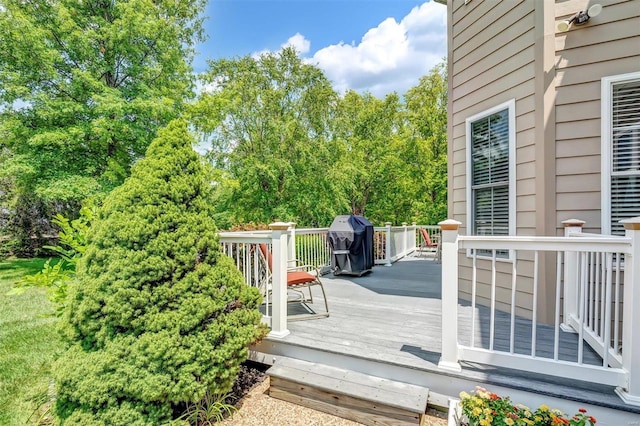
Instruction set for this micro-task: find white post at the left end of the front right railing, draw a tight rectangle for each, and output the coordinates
[438,219,462,371]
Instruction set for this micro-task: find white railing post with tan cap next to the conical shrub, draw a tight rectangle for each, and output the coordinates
[269,222,289,338]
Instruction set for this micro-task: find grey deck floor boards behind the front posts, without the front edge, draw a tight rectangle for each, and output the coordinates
[285,259,601,369]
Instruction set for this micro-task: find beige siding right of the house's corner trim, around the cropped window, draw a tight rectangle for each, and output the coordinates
[555,0,640,233]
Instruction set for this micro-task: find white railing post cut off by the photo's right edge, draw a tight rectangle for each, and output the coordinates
[616,217,640,406]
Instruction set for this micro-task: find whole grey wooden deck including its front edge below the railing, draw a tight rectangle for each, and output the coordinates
[253,257,640,420]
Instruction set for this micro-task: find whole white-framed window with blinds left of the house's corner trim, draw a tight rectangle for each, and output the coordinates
[466,100,515,257]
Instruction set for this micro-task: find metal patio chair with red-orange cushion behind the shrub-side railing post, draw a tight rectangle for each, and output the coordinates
[258,243,329,321]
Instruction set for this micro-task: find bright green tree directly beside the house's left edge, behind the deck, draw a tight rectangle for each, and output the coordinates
[334,63,447,224]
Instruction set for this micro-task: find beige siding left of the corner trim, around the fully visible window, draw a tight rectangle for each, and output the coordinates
[449,0,536,316]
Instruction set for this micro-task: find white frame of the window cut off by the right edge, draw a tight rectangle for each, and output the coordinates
[600,72,640,235]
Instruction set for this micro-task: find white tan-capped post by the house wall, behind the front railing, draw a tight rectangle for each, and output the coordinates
[560,219,585,333]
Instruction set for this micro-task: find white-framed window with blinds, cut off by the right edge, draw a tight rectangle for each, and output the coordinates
[601,73,640,235]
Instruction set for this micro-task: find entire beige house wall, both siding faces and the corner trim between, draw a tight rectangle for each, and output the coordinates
[448,0,640,320]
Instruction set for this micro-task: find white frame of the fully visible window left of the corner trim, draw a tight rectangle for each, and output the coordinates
[465,99,516,261]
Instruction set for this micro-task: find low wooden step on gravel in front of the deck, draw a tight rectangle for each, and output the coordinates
[267,357,429,425]
